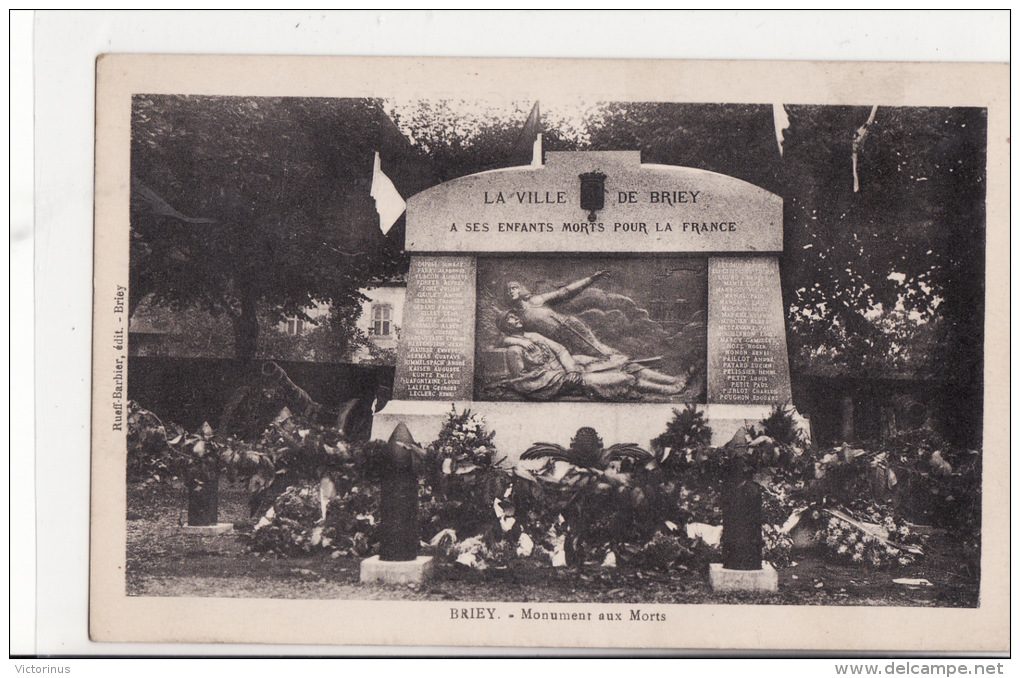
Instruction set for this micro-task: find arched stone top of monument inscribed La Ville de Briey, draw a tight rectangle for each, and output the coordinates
[406,151,782,254]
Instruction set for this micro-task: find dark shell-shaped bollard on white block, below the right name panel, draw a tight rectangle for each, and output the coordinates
[709,457,779,591]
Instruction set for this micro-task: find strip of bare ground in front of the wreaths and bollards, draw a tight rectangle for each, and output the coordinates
[126,482,978,607]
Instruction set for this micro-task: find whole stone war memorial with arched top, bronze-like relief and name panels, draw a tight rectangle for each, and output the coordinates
[372,151,792,459]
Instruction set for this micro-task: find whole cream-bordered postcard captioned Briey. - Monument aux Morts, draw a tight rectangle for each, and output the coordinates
[90,54,1010,653]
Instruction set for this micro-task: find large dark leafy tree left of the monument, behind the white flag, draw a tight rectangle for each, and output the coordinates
[131,95,419,362]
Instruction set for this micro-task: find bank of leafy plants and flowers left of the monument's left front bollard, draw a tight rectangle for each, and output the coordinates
[129,402,385,556]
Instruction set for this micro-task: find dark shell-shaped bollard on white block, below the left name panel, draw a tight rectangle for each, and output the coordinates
[361,422,432,584]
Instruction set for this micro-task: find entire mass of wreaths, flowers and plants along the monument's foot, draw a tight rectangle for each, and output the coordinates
[129,403,980,572]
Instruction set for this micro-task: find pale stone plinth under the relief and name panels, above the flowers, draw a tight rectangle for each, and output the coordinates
[372,401,810,462]
